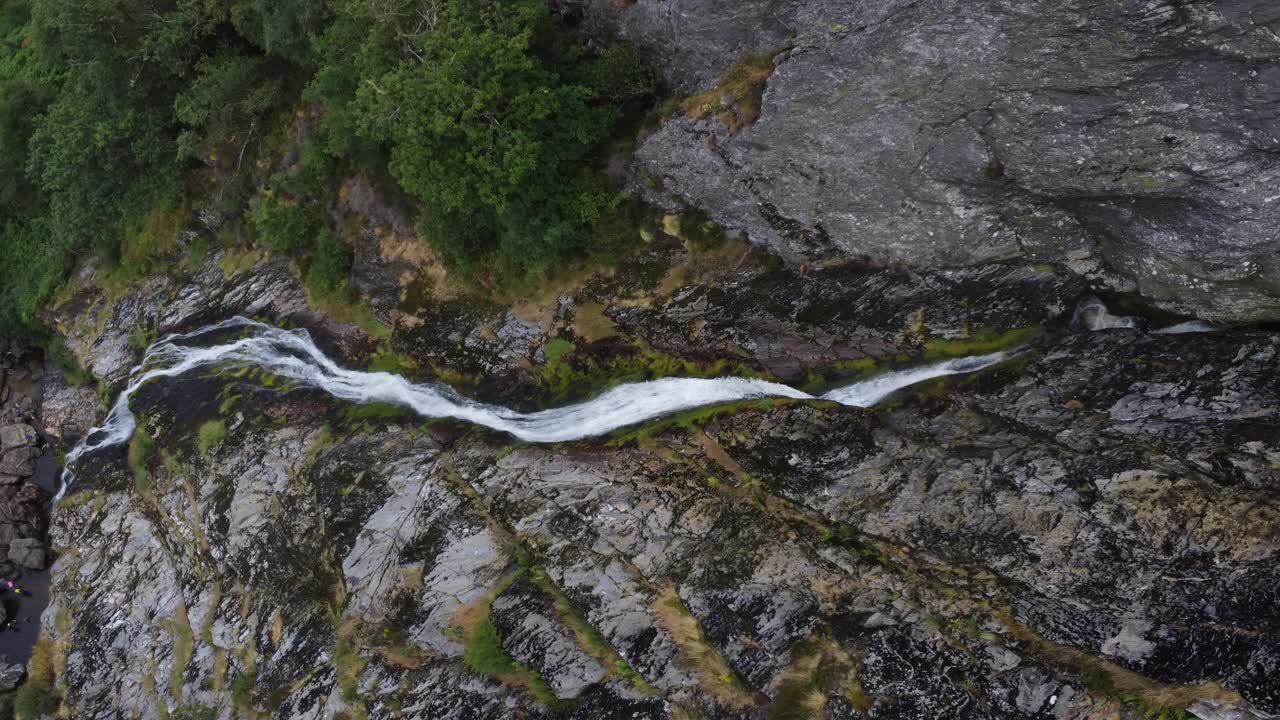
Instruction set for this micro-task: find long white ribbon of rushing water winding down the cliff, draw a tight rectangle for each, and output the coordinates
[58,318,1016,498]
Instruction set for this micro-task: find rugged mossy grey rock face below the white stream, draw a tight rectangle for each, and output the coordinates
[45,316,1280,720]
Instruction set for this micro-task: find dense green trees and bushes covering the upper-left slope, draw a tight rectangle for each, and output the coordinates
[0,0,655,334]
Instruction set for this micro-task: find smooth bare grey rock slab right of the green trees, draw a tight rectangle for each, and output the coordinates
[570,0,1280,320]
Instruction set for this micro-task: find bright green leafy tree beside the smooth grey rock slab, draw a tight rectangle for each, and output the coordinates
[308,0,653,273]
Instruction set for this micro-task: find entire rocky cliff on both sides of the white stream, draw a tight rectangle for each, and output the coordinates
[10,0,1280,720]
